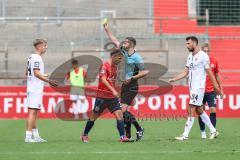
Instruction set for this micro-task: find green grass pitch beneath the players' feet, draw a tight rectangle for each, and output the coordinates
[0,119,240,160]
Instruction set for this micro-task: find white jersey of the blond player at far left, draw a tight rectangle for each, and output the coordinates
[27,54,44,93]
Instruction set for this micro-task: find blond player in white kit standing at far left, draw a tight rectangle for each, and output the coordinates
[25,39,57,143]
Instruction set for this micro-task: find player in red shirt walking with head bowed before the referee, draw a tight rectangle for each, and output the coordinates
[81,49,132,143]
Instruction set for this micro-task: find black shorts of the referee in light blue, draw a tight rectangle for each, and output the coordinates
[121,80,138,106]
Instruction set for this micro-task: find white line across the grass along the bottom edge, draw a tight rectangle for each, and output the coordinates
[0,150,240,155]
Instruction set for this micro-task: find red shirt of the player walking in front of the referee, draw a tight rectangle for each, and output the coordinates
[97,62,117,98]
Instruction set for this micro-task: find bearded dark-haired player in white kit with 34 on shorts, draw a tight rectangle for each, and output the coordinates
[169,36,222,140]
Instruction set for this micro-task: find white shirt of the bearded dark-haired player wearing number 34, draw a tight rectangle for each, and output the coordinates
[186,51,210,91]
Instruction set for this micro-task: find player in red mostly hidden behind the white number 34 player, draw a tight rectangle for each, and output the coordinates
[198,43,223,139]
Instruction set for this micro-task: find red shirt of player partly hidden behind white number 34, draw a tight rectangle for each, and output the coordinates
[205,56,219,93]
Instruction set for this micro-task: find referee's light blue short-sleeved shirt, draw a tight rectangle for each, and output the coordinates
[123,51,144,80]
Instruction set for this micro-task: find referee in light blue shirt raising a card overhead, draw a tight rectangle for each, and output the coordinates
[104,23,149,141]
